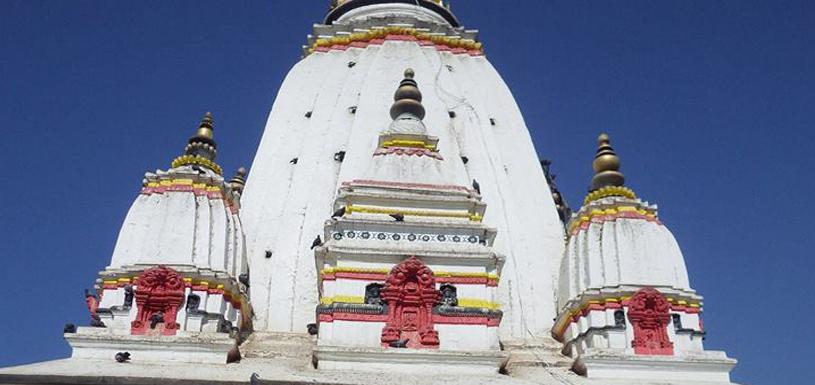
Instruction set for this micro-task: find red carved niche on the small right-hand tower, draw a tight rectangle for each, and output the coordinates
[628,288,674,356]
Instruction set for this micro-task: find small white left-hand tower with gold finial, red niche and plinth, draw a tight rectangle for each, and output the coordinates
[65,113,252,363]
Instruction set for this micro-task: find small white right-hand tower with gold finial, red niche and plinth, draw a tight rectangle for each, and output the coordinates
[552,134,736,384]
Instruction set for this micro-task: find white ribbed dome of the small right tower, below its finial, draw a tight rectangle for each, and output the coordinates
[558,197,692,307]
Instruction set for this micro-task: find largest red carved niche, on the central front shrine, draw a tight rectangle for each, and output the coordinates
[381,257,441,349]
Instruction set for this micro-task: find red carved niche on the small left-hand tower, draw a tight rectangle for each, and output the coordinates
[130,266,184,335]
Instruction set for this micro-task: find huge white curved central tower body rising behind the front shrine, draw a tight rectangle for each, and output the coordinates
[242,0,563,340]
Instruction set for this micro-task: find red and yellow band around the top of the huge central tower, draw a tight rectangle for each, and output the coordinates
[308,26,484,56]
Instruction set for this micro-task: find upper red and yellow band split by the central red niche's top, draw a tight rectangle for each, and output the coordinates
[320,267,499,287]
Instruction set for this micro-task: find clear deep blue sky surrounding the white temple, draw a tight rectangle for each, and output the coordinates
[0,0,815,384]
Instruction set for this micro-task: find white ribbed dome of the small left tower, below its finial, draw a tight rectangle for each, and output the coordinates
[109,166,246,277]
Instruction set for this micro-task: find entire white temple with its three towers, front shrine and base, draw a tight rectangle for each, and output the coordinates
[0,0,736,385]
